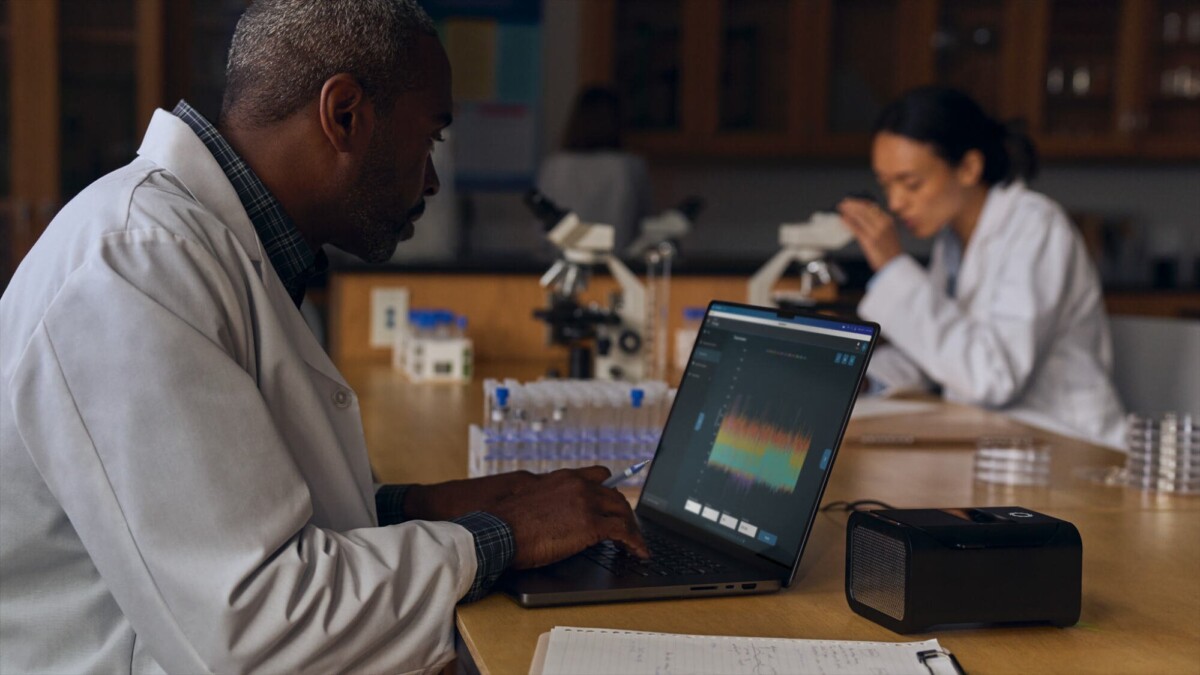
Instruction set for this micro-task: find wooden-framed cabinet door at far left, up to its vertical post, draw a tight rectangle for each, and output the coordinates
[2,0,163,280]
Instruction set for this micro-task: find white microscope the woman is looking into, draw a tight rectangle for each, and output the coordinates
[749,211,854,309]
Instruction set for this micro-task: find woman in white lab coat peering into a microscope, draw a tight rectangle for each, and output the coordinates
[838,86,1124,447]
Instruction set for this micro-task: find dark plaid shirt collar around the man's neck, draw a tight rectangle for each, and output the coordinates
[172,101,329,307]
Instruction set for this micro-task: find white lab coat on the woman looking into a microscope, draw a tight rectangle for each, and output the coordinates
[858,183,1124,448]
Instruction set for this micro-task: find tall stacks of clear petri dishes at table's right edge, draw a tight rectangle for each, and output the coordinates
[1124,412,1200,495]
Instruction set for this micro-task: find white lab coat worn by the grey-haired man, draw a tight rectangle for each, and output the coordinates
[0,110,476,673]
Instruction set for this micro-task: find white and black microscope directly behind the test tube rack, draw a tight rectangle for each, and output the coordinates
[524,190,647,381]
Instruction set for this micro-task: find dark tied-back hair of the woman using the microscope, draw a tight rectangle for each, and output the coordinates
[875,86,1038,186]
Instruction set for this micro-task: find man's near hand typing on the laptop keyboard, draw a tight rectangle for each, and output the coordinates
[487,466,649,569]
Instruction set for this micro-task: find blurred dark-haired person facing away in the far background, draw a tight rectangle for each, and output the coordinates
[538,86,652,253]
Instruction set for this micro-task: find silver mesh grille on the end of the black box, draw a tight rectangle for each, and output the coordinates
[850,527,906,621]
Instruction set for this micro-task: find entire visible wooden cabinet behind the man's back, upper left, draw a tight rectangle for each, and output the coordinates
[0,0,246,287]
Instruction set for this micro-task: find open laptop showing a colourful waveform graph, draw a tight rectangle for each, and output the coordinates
[500,301,880,607]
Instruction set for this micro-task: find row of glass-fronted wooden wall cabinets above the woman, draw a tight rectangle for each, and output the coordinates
[581,0,1200,159]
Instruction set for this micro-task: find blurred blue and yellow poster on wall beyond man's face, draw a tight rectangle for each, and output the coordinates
[421,0,541,191]
